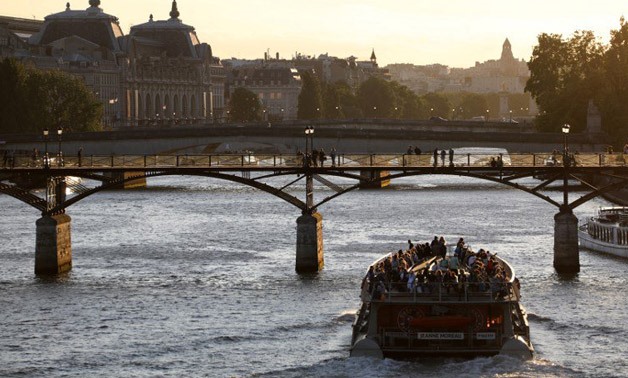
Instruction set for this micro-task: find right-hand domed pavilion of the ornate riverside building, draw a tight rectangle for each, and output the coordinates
[125,1,224,124]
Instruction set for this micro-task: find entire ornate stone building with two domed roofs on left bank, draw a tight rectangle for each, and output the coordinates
[20,0,224,128]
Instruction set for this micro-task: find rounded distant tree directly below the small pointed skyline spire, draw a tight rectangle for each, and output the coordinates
[357,76,395,118]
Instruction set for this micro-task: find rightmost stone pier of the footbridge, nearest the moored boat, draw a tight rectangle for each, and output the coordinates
[554,207,580,274]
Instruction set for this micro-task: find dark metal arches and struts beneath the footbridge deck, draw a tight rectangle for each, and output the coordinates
[0,166,628,215]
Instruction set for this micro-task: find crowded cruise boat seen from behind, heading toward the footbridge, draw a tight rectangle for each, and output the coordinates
[351,239,534,359]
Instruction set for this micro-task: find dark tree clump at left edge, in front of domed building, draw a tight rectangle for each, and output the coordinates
[0,58,102,134]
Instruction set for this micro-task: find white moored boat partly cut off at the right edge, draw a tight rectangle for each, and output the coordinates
[578,207,628,258]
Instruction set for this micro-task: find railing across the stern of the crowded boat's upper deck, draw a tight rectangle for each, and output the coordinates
[362,282,519,302]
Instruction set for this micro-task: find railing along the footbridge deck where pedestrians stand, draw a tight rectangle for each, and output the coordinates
[0,152,627,169]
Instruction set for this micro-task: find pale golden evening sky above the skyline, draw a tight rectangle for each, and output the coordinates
[0,0,628,68]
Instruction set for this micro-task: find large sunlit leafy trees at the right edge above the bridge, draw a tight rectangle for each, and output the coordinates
[526,17,628,145]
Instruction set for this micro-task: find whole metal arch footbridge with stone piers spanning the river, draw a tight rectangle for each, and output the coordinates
[0,150,628,274]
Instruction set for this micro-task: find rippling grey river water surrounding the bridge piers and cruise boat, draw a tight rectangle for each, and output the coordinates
[0,176,628,377]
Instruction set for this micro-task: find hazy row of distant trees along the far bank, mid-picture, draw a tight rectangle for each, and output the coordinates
[229,71,529,122]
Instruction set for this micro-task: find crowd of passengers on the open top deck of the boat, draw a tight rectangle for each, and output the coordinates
[364,236,508,299]
